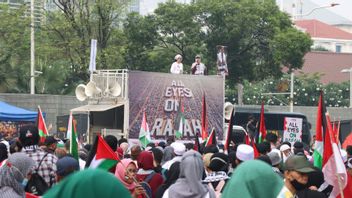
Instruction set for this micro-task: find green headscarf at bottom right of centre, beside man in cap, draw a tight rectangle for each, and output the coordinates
[222,160,283,198]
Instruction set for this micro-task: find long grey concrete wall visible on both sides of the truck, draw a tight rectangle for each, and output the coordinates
[0,93,352,133]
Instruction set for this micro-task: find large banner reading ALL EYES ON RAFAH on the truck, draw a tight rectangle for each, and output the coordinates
[128,71,224,139]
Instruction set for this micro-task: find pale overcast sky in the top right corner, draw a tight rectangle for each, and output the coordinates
[312,0,352,21]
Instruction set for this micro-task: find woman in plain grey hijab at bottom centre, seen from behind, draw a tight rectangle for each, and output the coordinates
[163,150,215,198]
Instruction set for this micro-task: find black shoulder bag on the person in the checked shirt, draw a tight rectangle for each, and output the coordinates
[25,153,49,195]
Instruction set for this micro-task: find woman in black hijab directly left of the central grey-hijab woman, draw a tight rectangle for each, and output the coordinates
[155,162,180,198]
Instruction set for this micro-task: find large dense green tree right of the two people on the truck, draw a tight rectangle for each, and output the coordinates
[197,0,311,83]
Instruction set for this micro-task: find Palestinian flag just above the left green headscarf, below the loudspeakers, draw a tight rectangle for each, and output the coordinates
[86,135,120,171]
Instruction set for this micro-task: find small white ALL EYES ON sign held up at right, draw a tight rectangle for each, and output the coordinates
[283,117,303,144]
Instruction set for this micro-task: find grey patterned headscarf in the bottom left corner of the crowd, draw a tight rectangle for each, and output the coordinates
[0,153,35,195]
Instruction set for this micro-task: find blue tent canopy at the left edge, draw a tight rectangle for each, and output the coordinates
[0,101,38,122]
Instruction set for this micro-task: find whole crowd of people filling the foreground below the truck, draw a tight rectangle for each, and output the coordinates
[0,126,352,198]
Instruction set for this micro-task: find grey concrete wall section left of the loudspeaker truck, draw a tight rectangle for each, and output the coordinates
[0,93,87,133]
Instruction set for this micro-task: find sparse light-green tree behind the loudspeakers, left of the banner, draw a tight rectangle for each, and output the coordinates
[46,0,128,82]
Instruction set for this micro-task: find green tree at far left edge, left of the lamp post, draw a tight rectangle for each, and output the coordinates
[0,5,30,92]
